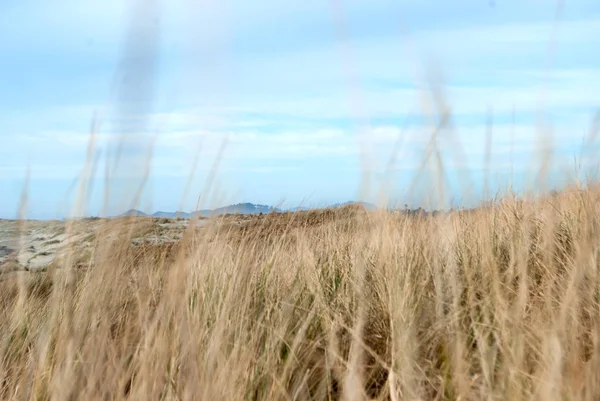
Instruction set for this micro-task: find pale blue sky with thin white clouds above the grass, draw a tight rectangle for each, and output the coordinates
[0,0,600,219]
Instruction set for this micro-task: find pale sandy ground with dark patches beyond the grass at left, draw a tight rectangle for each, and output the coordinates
[0,218,196,273]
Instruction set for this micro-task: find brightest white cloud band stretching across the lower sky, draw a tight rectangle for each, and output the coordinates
[0,113,584,179]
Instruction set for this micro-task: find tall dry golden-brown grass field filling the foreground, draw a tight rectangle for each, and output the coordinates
[0,187,600,401]
